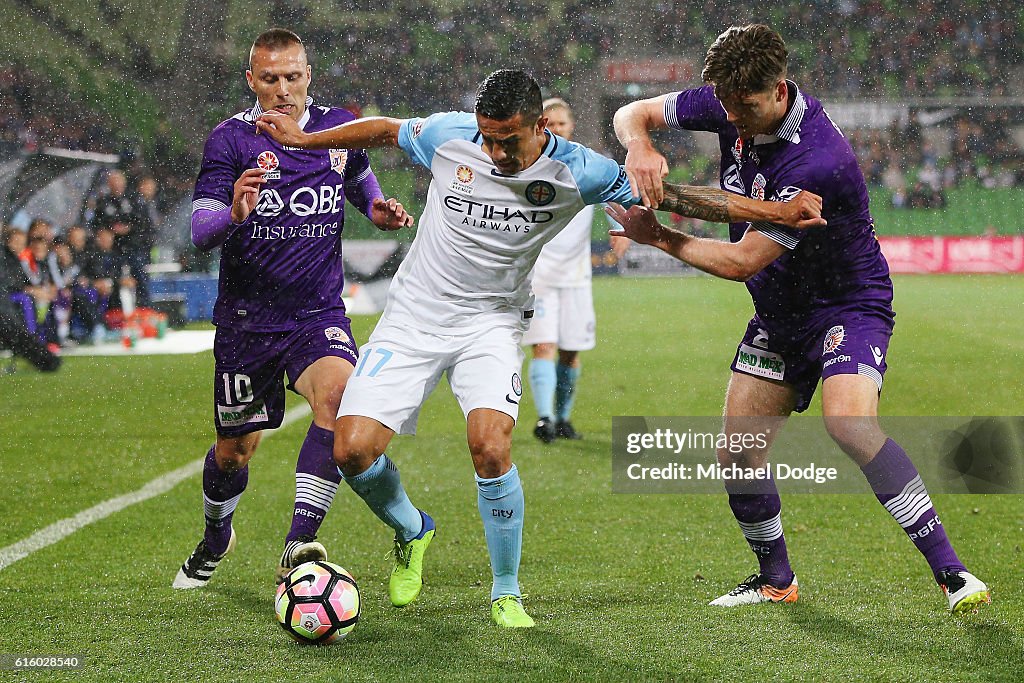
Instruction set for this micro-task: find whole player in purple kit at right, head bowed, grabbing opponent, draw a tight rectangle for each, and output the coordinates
[608,25,989,612]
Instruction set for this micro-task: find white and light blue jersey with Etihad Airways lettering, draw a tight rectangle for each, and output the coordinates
[384,112,636,335]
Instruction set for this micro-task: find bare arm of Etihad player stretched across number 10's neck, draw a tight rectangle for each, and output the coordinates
[255,112,402,150]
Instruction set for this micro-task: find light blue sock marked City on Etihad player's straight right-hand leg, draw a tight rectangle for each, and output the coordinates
[476,465,525,600]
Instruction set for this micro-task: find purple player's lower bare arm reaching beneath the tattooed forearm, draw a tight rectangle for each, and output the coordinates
[605,203,785,282]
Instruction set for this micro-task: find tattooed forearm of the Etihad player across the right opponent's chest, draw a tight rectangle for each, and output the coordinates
[657,182,827,229]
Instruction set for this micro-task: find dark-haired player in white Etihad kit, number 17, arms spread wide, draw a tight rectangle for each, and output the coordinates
[257,70,823,628]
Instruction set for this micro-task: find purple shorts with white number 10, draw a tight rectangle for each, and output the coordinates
[213,310,359,436]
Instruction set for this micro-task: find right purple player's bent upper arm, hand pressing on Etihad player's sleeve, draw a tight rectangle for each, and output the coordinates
[613,94,669,209]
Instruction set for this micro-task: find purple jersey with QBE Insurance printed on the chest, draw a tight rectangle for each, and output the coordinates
[193,98,376,332]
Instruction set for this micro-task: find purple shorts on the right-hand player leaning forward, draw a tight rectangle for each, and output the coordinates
[732,312,893,413]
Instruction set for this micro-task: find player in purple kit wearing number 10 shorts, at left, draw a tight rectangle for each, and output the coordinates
[173,29,413,589]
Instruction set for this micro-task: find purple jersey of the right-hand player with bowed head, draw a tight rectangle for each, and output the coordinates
[665,81,894,334]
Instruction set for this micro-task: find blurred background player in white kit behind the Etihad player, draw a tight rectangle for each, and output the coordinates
[522,97,630,443]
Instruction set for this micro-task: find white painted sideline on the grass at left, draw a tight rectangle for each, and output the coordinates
[0,403,311,571]
